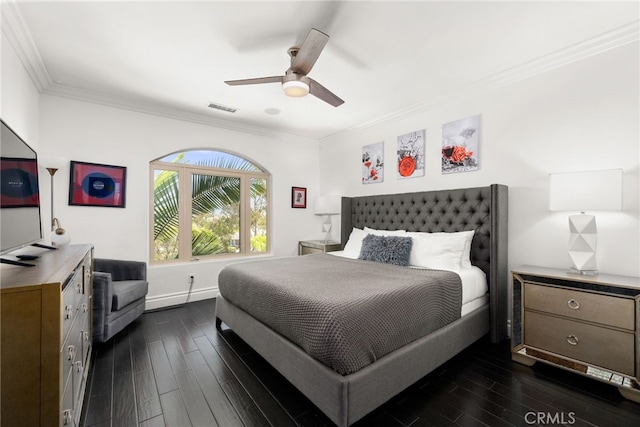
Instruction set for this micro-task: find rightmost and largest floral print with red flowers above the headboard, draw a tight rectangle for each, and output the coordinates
[442,115,480,174]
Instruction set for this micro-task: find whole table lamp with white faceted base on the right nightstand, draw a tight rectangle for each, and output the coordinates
[549,169,622,275]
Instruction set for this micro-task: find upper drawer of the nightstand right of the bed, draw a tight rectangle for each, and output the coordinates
[524,283,635,331]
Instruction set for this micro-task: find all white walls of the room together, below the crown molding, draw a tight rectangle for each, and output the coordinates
[0,26,640,308]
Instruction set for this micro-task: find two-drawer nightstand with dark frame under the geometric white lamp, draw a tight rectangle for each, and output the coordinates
[511,266,640,402]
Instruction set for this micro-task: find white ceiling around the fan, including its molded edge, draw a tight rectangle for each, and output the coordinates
[2,0,639,140]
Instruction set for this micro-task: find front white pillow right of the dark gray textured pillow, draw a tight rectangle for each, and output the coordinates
[407,230,475,271]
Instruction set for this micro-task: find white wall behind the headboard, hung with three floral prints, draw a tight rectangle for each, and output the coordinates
[320,43,640,276]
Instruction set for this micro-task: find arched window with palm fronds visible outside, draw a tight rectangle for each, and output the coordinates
[150,150,270,263]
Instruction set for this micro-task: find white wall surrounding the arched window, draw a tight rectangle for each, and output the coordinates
[35,95,321,308]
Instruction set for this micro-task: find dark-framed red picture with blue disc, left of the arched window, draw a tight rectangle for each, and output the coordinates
[69,161,127,208]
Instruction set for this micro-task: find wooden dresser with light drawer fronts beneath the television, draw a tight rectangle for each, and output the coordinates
[0,245,93,427]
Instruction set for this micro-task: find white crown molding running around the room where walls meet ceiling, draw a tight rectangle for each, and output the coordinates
[1,0,640,141]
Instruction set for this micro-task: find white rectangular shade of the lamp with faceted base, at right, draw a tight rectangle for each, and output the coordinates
[549,169,622,212]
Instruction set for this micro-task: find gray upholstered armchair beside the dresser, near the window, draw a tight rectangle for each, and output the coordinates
[93,258,149,342]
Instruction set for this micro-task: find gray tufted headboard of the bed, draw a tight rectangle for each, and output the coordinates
[341,184,508,342]
